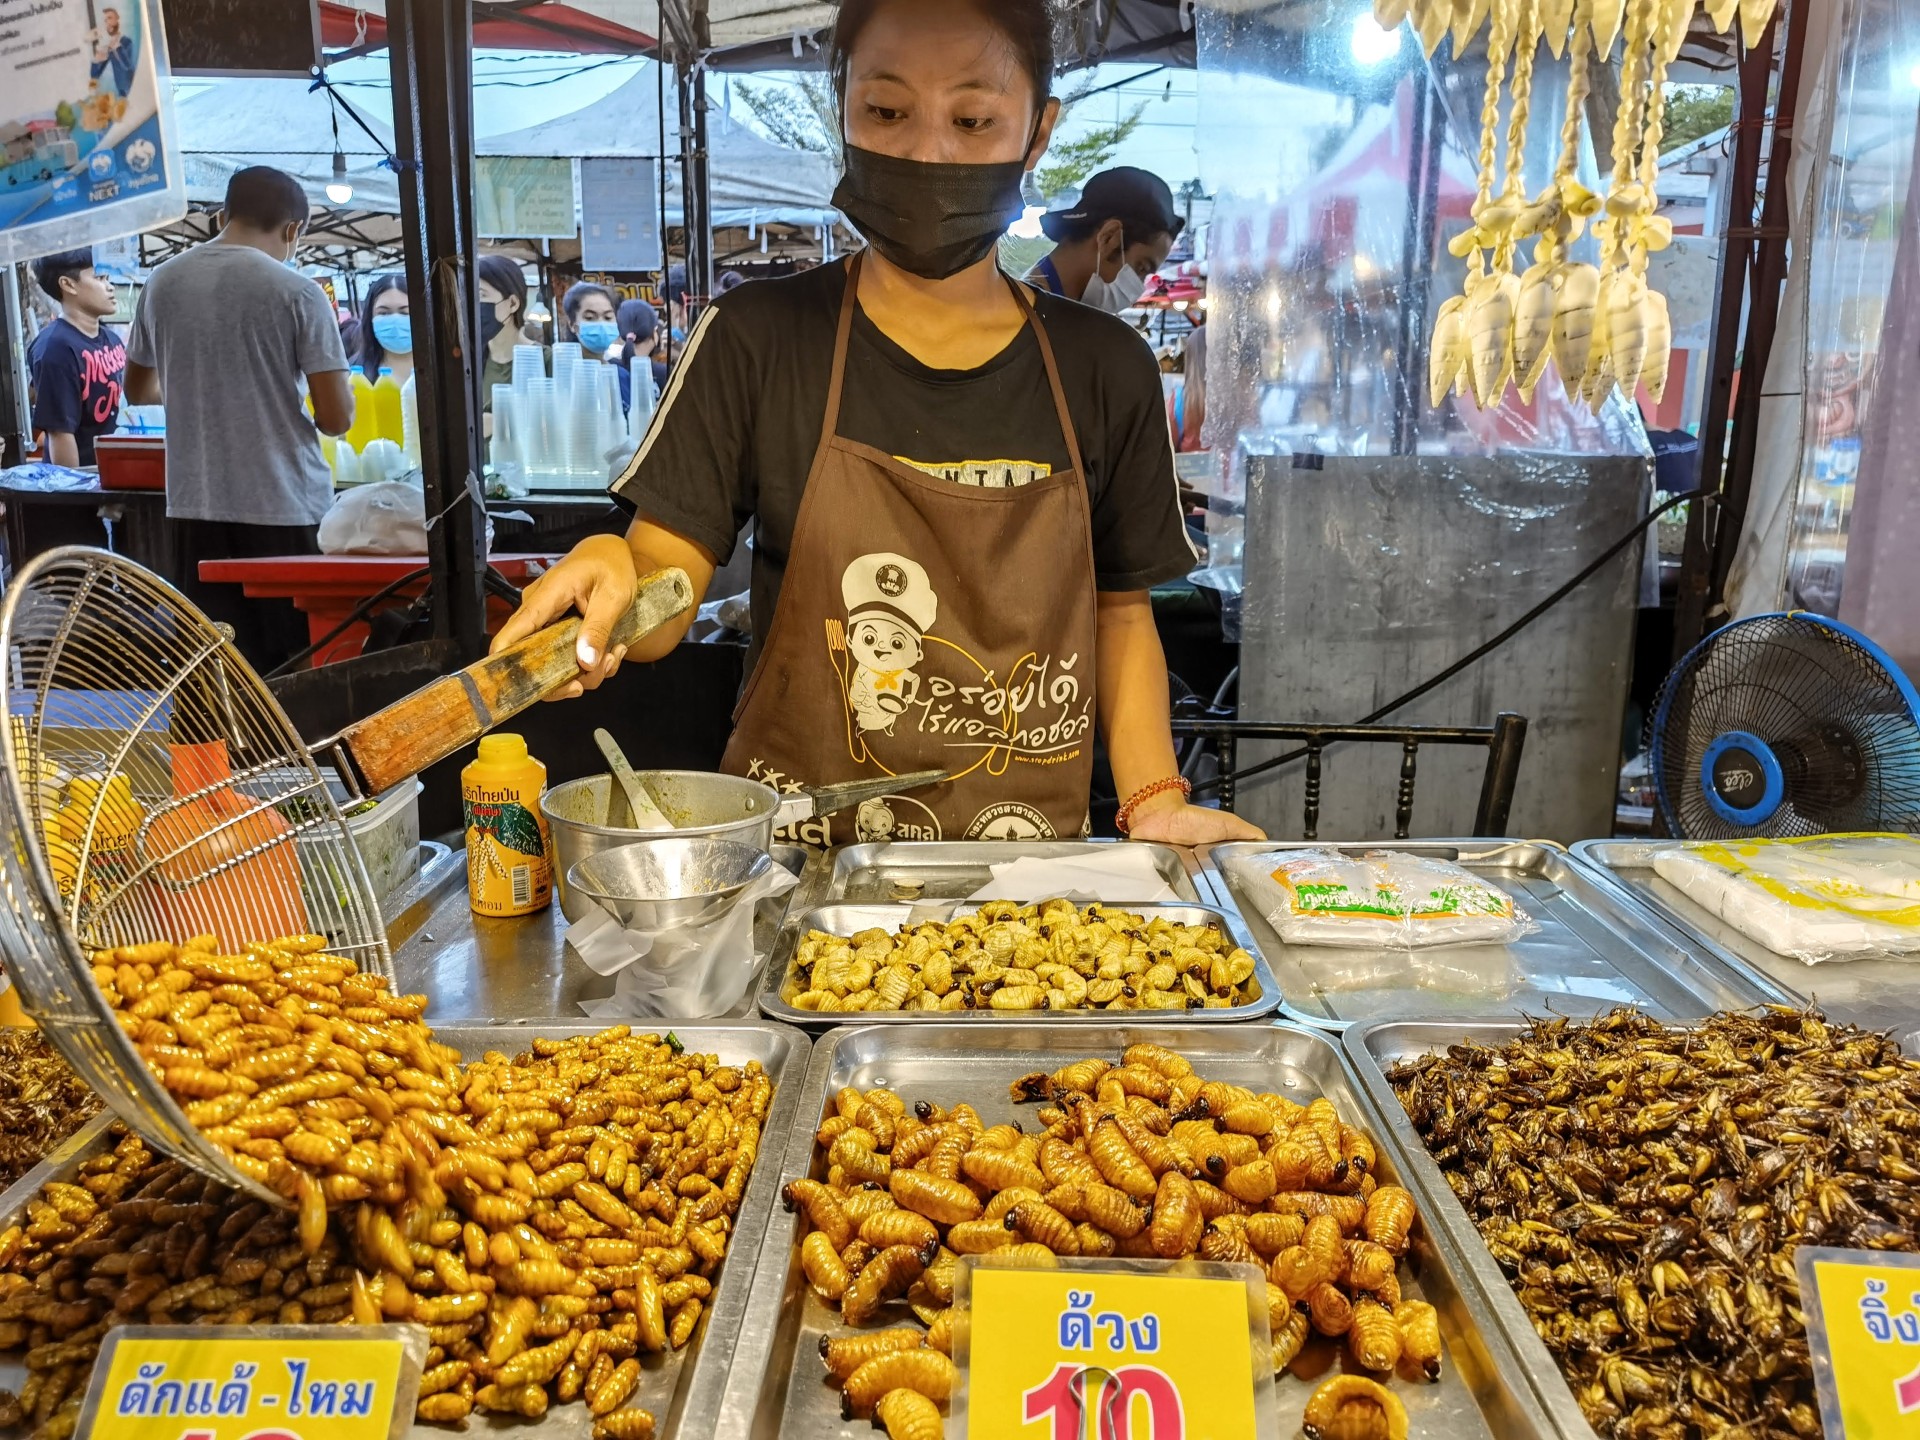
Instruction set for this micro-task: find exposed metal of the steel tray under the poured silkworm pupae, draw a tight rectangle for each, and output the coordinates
[0,1021,816,1440]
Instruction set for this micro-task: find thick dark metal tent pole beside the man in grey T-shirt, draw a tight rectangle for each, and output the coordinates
[386,0,486,657]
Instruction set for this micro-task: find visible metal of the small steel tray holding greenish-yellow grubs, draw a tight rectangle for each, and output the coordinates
[760,900,1281,1029]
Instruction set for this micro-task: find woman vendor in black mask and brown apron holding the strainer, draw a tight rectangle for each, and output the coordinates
[495,0,1258,845]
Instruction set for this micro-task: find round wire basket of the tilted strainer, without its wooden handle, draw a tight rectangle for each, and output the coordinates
[0,549,392,1204]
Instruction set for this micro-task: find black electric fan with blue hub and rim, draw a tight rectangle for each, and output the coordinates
[1649,611,1920,839]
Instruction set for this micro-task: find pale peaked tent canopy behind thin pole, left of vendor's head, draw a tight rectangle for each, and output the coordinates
[474,65,839,228]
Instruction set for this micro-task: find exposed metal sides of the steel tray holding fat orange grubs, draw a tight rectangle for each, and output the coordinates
[718,1021,1551,1440]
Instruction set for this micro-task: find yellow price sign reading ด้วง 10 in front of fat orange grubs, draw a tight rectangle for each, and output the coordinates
[954,1256,1279,1440]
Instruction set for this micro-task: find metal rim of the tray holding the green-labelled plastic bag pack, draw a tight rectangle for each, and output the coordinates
[1196,837,1791,1035]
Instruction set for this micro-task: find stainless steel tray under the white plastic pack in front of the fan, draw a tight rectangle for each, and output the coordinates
[1572,839,1920,1048]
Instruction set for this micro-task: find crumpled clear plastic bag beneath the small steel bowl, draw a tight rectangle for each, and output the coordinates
[566,864,801,1020]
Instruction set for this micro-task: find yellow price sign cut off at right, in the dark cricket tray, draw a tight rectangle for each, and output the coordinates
[1795,1246,1920,1440]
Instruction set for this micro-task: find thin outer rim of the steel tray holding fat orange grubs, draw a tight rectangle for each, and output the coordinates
[718,1016,1559,1440]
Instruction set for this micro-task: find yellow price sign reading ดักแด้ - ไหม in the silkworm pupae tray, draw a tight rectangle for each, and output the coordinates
[79,1325,426,1440]
